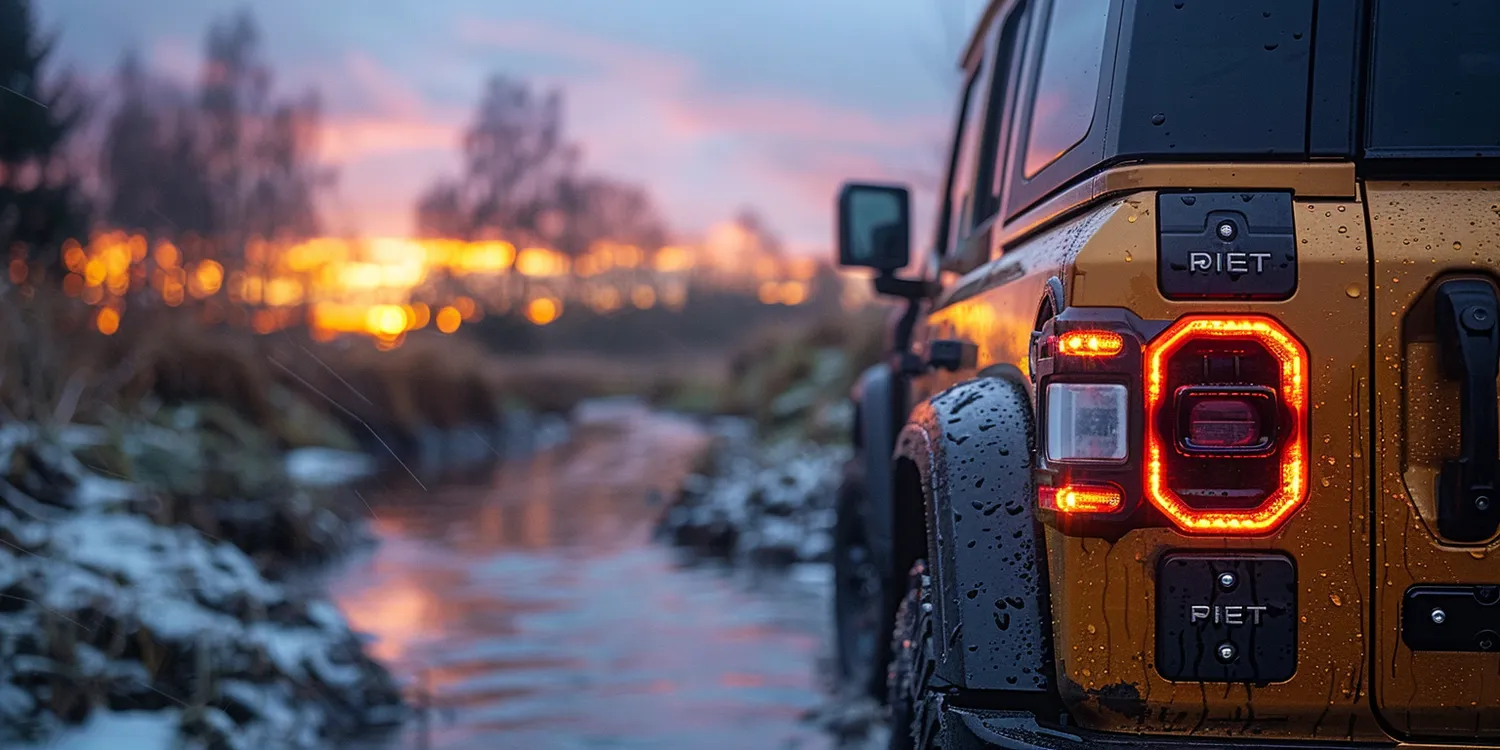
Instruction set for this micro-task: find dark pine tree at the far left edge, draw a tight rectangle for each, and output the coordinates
[0,0,86,265]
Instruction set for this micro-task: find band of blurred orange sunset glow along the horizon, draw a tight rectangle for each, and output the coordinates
[41,230,866,347]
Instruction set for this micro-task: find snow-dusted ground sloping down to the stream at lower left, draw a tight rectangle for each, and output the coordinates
[0,425,405,750]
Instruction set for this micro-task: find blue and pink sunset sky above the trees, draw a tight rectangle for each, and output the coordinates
[38,0,980,251]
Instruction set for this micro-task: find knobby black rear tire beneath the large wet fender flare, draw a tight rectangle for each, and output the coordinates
[887,560,942,750]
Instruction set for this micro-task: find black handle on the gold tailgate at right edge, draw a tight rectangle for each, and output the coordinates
[1436,279,1500,542]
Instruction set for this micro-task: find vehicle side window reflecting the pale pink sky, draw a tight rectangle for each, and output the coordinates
[1023,0,1110,180]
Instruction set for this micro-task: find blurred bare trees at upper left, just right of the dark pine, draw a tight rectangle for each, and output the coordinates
[101,11,333,267]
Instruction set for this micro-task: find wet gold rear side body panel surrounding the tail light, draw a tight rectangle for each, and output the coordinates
[930,172,1386,741]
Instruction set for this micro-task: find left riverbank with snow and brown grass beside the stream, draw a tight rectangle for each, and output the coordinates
[0,417,407,749]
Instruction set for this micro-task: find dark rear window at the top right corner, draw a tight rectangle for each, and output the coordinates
[1365,0,1500,156]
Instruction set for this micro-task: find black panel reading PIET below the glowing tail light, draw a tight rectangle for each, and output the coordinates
[1157,552,1298,684]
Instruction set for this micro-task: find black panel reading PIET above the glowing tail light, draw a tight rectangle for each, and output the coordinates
[1157,192,1298,300]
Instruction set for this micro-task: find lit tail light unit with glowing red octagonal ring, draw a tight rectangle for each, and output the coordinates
[1032,308,1310,536]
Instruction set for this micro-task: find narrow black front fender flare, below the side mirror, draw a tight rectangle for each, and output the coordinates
[854,363,906,570]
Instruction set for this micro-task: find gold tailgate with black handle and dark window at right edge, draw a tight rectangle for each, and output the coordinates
[1362,2,1500,744]
